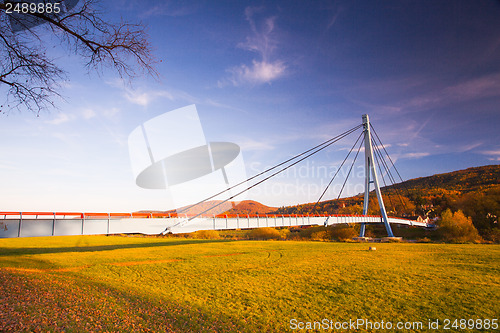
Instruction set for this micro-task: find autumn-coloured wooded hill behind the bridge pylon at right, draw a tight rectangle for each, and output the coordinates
[276,165,500,240]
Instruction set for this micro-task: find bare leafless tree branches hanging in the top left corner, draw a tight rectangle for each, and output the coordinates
[0,0,157,113]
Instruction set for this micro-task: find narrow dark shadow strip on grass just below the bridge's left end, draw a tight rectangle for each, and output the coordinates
[0,239,233,256]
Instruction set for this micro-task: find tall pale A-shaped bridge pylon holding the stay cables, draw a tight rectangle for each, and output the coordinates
[359,114,394,237]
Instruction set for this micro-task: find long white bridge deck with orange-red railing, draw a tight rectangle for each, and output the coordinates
[0,212,428,238]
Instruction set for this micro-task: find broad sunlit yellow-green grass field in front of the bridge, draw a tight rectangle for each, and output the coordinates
[0,236,500,332]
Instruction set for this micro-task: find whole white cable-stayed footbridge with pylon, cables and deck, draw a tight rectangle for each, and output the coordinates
[0,115,429,238]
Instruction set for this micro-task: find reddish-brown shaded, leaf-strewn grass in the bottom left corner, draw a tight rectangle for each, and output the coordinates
[0,270,256,332]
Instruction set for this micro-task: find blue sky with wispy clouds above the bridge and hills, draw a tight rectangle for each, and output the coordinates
[0,0,500,212]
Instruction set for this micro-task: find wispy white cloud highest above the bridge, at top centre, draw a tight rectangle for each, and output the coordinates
[219,7,287,87]
